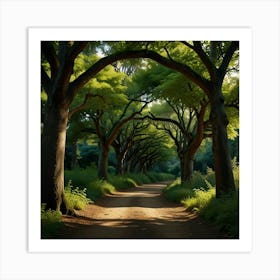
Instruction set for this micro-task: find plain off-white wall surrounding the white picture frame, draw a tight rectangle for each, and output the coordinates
[0,0,280,280]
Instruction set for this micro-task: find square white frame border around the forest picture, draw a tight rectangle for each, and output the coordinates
[28,27,252,253]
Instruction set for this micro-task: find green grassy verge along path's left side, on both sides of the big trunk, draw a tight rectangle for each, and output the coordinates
[41,167,174,238]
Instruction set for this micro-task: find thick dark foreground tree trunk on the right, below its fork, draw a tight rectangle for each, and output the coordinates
[210,86,235,197]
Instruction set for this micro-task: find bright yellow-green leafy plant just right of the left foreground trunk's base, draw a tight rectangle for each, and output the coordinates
[64,180,91,211]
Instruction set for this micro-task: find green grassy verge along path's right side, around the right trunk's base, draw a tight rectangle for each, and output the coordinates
[163,164,239,238]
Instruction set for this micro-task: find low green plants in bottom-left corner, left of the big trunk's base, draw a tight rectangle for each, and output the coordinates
[41,204,64,238]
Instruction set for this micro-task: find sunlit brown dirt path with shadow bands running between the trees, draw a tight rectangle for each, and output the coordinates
[56,183,229,239]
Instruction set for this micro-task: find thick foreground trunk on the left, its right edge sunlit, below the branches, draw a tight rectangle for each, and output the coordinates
[41,105,68,211]
